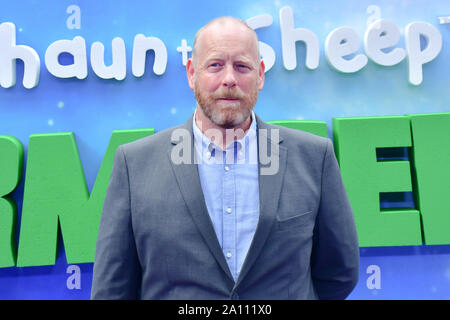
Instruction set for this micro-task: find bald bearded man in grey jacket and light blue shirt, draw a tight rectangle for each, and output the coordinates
[92,17,359,300]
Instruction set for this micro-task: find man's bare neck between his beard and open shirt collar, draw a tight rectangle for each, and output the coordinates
[195,105,252,150]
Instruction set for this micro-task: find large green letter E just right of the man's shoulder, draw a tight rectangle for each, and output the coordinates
[333,116,422,247]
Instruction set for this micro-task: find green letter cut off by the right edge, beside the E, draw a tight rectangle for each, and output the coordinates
[410,113,450,244]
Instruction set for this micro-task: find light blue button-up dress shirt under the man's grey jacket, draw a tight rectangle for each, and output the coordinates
[193,112,259,281]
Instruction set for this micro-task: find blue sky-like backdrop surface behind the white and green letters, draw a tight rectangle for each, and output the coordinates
[0,0,450,299]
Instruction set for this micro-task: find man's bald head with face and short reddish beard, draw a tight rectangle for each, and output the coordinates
[186,17,265,131]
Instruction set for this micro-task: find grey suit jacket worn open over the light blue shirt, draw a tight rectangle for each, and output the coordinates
[91,117,359,299]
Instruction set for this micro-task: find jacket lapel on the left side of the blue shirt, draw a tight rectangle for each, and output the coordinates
[168,116,234,282]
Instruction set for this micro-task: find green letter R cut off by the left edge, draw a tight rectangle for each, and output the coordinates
[0,136,23,268]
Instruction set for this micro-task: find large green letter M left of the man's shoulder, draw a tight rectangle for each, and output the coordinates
[17,129,153,267]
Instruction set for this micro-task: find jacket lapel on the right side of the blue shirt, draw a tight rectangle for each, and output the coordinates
[235,116,287,287]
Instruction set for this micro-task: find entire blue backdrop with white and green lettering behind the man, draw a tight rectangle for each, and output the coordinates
[0,0,450,299]
